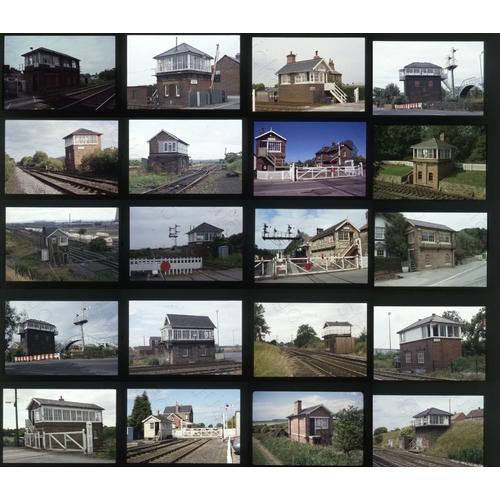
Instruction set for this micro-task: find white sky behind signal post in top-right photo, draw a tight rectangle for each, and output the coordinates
[373,40,484,92]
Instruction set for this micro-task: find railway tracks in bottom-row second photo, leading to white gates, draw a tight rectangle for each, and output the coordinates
[127,439,209,464]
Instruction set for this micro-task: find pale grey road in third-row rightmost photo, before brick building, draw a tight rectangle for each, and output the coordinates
[375,262,487,287]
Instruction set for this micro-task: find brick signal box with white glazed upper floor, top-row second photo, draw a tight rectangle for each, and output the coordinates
[153,43,229,108]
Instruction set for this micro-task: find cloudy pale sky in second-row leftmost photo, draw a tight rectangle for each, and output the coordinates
[5,120,118,161]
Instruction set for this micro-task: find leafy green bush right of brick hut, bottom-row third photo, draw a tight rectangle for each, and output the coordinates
[333,405,363,456]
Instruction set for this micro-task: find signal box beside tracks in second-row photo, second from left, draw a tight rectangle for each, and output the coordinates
[147,130,189,174]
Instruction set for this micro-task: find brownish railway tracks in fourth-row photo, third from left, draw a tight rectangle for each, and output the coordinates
[285,348,367,377]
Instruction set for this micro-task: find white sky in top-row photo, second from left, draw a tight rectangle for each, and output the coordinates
[127,35,241,86]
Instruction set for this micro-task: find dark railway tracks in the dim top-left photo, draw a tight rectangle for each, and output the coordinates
[43,81,116,111]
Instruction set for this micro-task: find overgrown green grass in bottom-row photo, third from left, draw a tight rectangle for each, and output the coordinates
[254,434,363,467]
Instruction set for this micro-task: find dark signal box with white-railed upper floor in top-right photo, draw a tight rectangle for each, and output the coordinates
[399,62,447,104]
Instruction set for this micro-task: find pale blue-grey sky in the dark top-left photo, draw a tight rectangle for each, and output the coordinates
[4,35,116,75]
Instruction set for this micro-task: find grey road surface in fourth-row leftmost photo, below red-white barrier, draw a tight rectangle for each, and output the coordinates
[5,358,118,376]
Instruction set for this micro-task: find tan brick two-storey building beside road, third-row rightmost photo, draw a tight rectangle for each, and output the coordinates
[405,219,456,270]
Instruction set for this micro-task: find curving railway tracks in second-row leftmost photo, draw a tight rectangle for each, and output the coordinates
[18,167,118,195]
